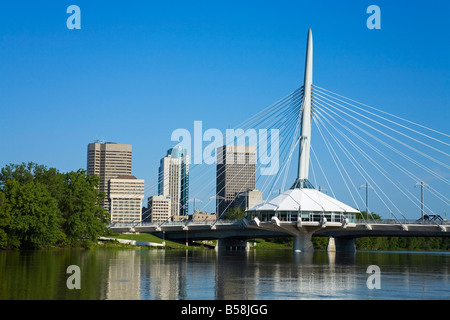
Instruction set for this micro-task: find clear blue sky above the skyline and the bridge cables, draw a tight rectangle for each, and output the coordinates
[0,0,450,218]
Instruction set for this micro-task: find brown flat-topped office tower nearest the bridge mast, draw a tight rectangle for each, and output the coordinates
[216,145,256,218]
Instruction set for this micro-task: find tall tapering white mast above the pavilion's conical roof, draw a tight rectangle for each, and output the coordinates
[291,28,314,189]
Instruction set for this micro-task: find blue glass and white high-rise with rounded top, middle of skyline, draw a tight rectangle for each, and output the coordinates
[158,147,189,217]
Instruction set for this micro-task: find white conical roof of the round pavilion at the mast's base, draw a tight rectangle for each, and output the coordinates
[247,188,359,213]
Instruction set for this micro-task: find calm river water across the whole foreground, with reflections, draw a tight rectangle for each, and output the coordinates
[0,249,450,300]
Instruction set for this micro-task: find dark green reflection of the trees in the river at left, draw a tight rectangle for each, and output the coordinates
[0,249,107,300]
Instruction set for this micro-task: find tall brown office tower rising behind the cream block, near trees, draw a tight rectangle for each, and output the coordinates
[87,141,132,211]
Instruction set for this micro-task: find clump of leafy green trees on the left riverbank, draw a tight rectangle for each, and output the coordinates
[0,162,109,247]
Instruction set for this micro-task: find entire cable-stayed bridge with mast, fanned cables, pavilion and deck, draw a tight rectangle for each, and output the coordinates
[111,30,450,252]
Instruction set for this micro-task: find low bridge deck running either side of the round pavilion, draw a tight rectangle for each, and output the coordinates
[110,219,450,251]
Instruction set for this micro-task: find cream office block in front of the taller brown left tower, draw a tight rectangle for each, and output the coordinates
[108,175,144,223]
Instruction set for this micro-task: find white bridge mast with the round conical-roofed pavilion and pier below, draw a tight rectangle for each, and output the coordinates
[247,29,359,252]
